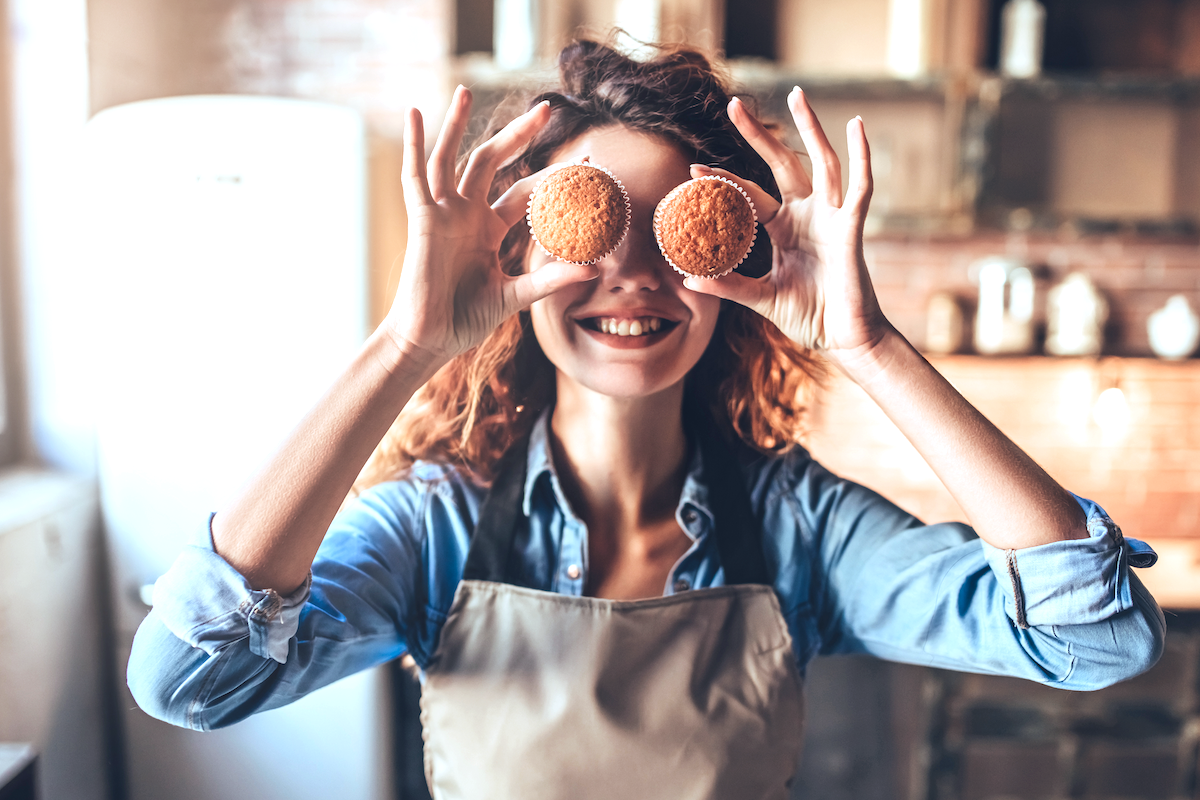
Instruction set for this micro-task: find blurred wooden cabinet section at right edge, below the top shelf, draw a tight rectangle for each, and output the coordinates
[966,76,1200,235]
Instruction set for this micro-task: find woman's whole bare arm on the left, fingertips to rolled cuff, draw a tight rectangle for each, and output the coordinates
[212,92,595,594]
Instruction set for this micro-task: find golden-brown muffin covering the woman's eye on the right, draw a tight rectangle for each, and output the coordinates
[654,175,758,278]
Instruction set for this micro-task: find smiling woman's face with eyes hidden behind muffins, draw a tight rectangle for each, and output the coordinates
[527,126,721,398]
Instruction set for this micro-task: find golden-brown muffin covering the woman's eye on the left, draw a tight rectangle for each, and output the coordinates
[528,162,629,264]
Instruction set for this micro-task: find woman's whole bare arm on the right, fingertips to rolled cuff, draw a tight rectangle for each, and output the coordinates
[686,88,1088,549]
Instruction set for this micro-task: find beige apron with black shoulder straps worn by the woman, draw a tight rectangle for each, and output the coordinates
[421,412,803,800]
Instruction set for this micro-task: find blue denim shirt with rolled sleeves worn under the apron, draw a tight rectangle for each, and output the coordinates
[128,415,1165,730]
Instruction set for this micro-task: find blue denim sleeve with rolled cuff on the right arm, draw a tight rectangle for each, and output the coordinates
[790,462,1165,690]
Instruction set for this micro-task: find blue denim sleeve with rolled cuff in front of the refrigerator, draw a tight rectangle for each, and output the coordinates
[127,485,422,730]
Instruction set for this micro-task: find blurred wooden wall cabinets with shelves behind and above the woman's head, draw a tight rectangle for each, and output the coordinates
[456,0,1200,236]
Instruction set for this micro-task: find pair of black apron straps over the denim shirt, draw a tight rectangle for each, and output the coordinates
[462,404,770,588]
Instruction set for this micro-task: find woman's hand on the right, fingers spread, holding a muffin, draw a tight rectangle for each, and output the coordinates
[685,88,890,367]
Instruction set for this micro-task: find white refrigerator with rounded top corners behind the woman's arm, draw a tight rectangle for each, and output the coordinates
[80,96,392,800]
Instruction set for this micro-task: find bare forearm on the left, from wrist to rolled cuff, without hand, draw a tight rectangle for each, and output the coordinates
[212,330,440,594]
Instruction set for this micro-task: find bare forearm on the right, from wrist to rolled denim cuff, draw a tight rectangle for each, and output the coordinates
[839,326,1087,549]
